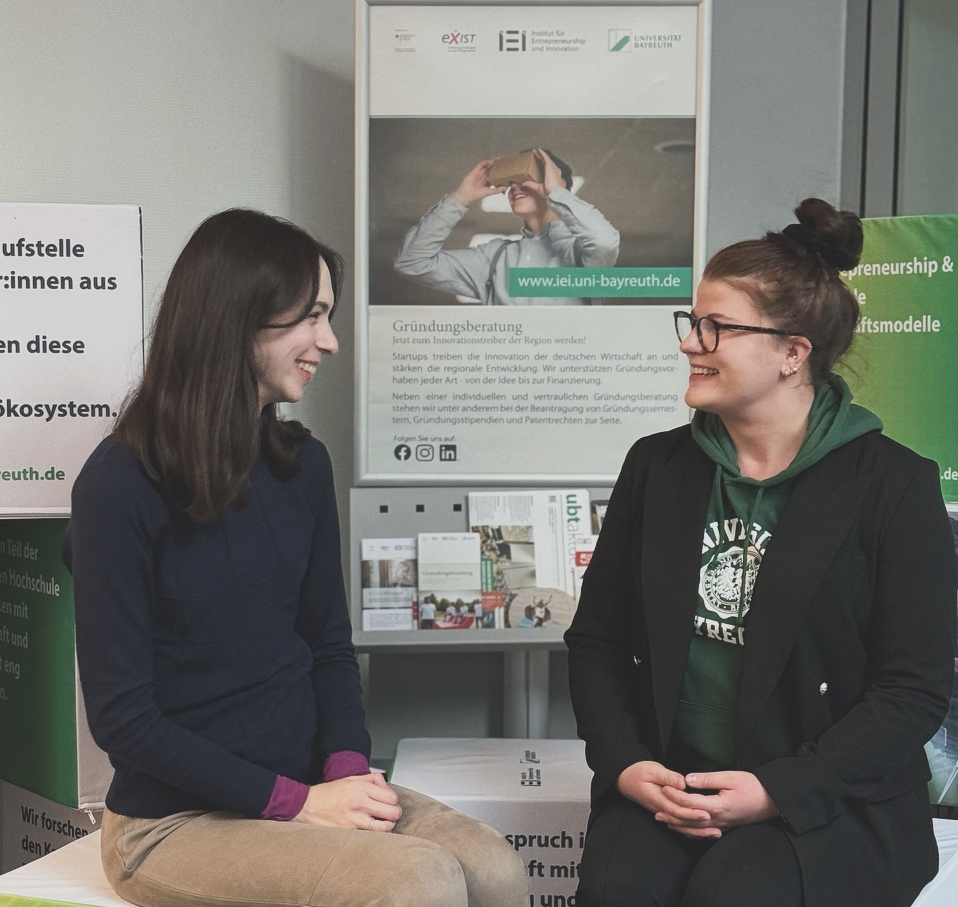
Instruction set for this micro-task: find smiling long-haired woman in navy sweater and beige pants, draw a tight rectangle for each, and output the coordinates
[64,210,528,907]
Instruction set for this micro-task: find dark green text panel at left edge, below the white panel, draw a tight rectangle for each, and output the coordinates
[0,519,77,806]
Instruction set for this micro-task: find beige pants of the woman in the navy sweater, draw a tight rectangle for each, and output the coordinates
[101,786,529,907]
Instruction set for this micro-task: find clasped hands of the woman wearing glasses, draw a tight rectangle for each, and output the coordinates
[617,762,780,839]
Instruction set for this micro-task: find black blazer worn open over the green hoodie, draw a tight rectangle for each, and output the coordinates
[566,426,956,907]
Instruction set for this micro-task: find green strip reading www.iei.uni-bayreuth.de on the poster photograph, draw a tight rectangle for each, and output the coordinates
[509,268,692,298]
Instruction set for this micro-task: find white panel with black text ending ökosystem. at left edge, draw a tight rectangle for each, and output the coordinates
[0,203,143,517]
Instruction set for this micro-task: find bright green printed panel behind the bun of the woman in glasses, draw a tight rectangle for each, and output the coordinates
[842,214,958,501]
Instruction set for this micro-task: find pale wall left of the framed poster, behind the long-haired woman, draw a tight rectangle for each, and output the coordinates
[0,0,354,510]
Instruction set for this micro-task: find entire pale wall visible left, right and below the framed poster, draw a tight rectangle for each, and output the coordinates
[0,0,845,758]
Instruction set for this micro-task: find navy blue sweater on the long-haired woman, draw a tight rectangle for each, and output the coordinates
[64,438,370,818]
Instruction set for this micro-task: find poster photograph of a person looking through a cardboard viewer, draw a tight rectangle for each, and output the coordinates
[369,117,695,306]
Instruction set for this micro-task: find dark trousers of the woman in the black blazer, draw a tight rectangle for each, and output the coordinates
[576,793,802,907]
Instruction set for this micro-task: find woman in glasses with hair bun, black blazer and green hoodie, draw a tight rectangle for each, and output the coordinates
[566,198,956,907]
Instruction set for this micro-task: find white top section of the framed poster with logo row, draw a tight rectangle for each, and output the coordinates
[369,6,698,117]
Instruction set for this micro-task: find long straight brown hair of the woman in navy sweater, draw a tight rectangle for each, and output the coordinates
[114,208,344,522]
